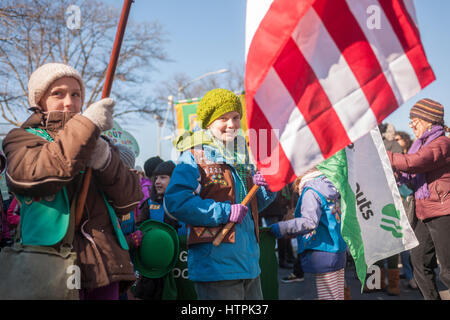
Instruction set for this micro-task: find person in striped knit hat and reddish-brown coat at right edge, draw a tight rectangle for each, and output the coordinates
[388,99,450,300]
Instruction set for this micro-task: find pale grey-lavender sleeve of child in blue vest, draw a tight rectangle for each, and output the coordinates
[278,190,322,236]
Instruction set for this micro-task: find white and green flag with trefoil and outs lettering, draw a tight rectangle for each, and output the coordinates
[317,127,419,285]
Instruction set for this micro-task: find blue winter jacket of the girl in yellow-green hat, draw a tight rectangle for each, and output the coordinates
[164,145,276,281]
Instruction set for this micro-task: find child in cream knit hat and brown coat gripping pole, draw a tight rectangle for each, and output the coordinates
[3,63,142,299]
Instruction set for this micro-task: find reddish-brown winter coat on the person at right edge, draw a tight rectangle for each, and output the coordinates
[388,136,450,220]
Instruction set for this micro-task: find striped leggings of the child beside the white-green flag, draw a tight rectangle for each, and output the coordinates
[316,269,345,300]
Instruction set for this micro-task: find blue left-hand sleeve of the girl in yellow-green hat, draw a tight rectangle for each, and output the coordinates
[164,151,231,227]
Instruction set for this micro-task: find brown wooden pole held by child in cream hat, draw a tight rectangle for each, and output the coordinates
[75,0,134,226]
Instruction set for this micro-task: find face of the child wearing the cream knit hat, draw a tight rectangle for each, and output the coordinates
[39,77,81,113]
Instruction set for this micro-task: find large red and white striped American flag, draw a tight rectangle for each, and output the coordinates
[245,0,435,190]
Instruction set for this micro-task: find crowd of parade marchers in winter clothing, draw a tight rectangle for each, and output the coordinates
[0,63,450,300]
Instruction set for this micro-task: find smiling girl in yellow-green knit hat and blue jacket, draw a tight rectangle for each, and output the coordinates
[164,89,276,300]
